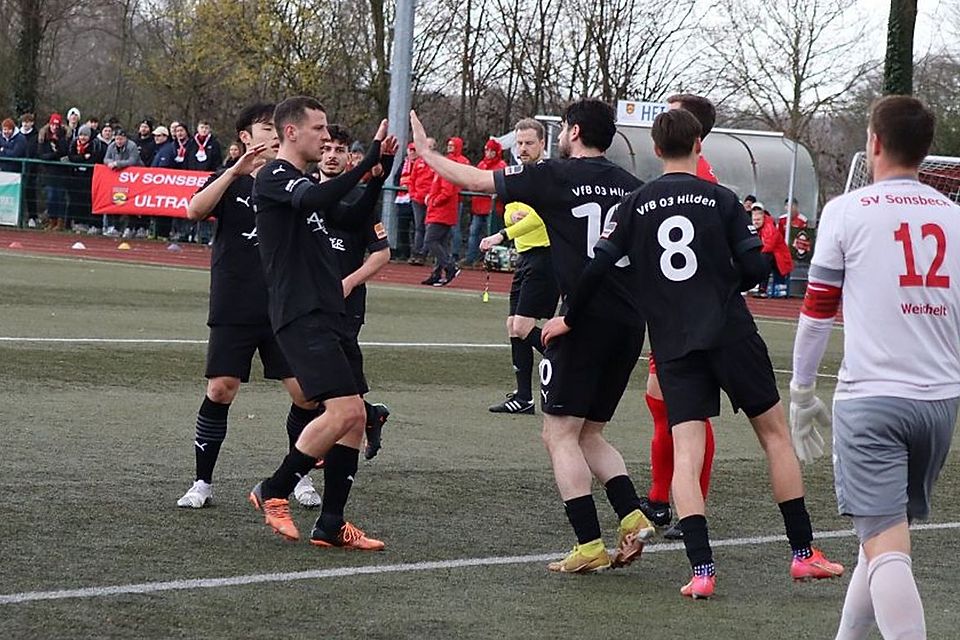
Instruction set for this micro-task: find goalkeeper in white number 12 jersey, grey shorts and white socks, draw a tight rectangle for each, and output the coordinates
[790,96,960,640]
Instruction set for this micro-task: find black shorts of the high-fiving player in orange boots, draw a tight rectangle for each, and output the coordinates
[277,311,360,402]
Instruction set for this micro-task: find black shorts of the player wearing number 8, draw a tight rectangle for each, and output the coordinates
[657,333,780,427]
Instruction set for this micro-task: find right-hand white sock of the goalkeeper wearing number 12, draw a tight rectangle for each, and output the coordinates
[868,552,927,640]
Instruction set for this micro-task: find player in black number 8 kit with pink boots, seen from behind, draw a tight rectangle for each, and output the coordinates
[543,110,843,598]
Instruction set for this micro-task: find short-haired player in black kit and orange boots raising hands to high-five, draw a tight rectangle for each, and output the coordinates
[249,96,397,550]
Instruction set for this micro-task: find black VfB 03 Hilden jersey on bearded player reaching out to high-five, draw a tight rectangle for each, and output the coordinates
[494,157,643,325]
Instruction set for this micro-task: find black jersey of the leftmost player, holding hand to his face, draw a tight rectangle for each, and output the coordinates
[200,171,270,326]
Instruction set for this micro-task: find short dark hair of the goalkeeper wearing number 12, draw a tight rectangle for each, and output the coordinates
[869,96,936,167]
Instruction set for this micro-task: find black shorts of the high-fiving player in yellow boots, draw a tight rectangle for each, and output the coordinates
[540,316,644,422]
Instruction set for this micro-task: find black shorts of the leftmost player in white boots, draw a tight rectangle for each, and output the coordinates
[204,323,293,382]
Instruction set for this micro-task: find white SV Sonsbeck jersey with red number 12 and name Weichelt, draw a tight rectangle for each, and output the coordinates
[804,179,960,400]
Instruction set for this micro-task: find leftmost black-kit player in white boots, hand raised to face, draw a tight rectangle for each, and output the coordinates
[177,103,320,509]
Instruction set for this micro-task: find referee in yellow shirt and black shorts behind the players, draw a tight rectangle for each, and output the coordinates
[480,118,560,414]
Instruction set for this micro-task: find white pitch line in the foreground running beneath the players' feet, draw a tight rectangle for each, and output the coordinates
[0,522,960,604]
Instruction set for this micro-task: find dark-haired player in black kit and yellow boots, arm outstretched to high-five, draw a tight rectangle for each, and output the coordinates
[410,99,654,573]
